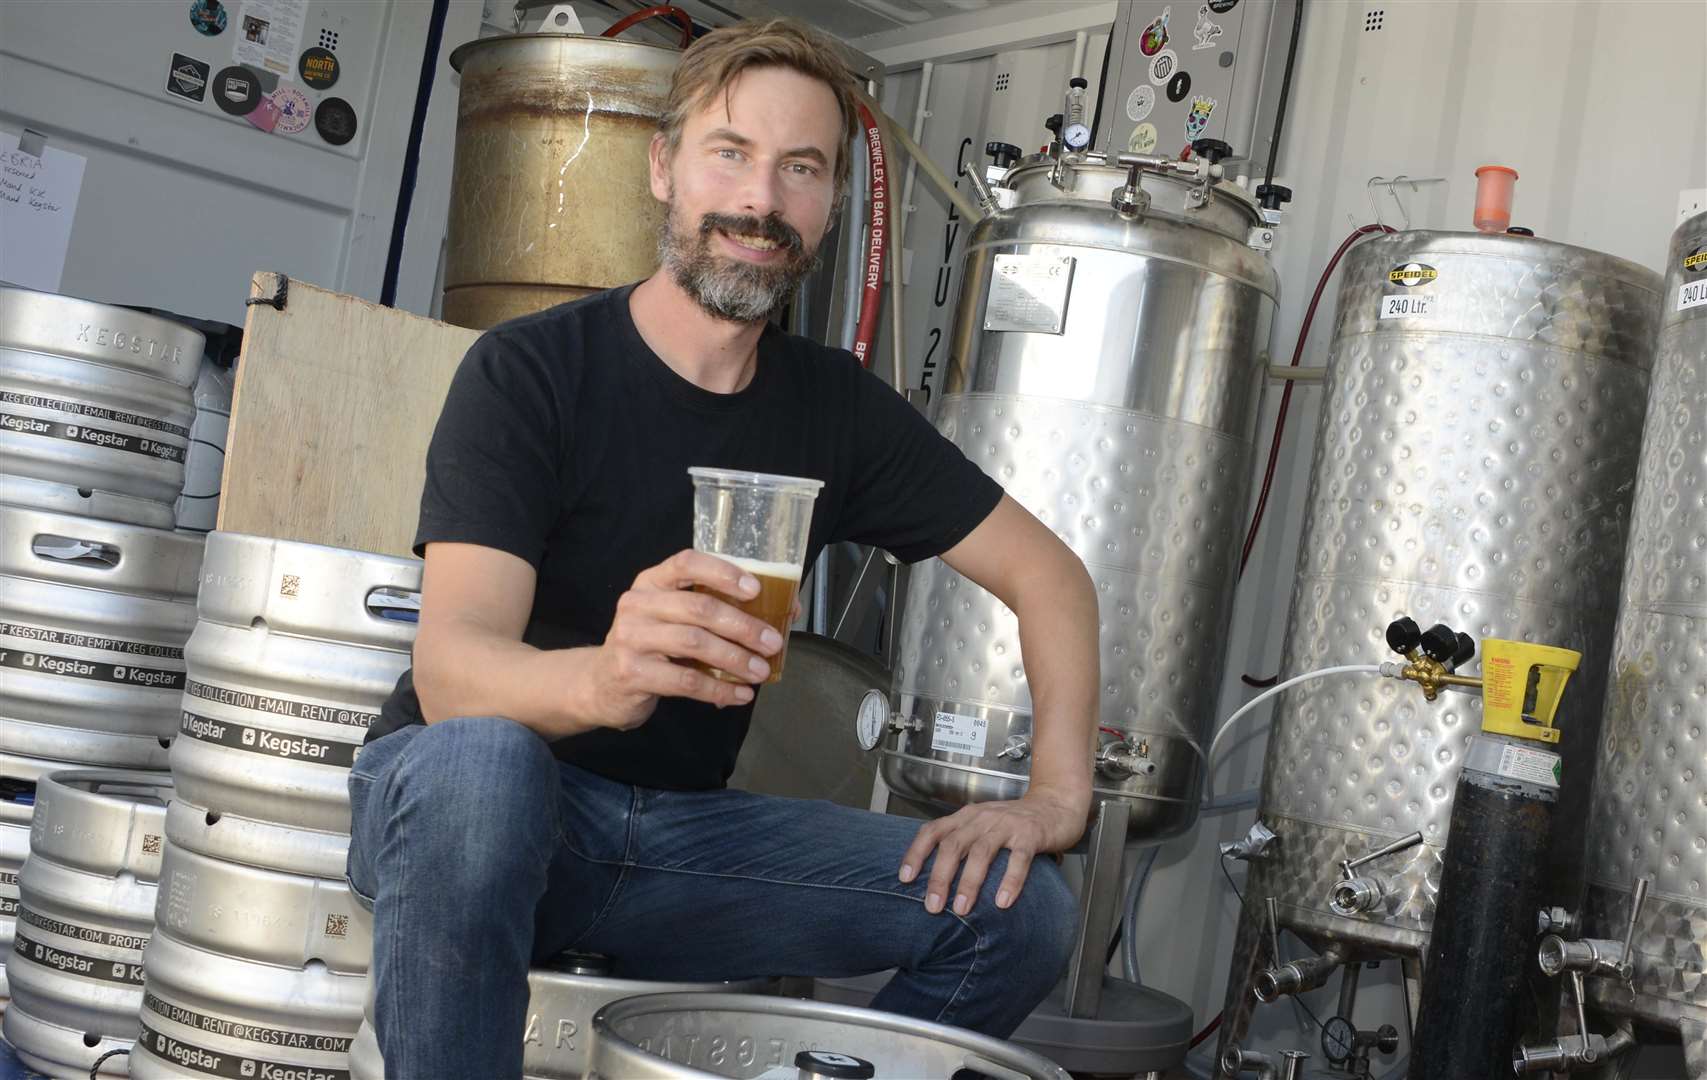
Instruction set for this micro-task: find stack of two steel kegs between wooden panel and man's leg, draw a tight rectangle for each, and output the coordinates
[130,532,420,1080]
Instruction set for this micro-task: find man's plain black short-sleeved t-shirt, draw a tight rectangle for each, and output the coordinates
[367,285,1002,790]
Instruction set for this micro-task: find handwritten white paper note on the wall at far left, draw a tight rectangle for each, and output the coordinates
[0,131,87,292]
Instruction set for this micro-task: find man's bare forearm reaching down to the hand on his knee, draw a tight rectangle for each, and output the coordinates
[1014,548,1099,812]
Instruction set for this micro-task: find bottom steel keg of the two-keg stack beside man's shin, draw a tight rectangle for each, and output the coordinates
[130,842,372,1078]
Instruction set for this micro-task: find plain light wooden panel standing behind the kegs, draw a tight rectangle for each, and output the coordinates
[218,273,480,556]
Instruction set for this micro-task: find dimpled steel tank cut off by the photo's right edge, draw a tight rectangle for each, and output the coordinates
[1582,215,1707,1080]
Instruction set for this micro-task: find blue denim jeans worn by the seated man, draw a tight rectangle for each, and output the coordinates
[348,718,1079,1080]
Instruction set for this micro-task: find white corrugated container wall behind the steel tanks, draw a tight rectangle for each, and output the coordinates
[867,0,1707,1077]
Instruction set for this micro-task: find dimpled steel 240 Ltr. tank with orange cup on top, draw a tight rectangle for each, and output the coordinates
[1222,232,1661,1071]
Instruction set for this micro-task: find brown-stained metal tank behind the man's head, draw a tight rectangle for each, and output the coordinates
[444,34,681,328]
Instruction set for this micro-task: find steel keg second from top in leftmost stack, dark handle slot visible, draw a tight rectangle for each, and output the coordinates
[0,507,201,768]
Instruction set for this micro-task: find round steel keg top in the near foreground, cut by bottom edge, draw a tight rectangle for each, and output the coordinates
[587,993,1069,1080]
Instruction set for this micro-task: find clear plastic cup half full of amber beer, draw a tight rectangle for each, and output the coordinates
[688,467,824,682]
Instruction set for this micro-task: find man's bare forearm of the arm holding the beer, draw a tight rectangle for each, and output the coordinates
[415,621,594,739]
